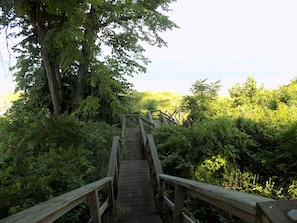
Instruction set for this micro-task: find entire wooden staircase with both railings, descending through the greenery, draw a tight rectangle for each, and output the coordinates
[0,110,297,223]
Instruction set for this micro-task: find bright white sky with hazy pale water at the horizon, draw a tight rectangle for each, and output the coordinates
[0,0,297,94]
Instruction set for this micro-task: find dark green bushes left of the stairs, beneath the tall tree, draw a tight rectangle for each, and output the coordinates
[0,101,119,220]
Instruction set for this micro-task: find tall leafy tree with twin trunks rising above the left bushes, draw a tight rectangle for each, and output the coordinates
[0,0,176,116]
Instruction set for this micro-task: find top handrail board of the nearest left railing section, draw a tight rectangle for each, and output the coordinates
[0,177,112,223]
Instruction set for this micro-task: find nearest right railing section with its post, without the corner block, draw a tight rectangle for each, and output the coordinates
[159,174,275,222]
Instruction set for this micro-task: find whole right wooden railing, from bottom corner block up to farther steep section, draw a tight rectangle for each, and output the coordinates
[139,115,297,223]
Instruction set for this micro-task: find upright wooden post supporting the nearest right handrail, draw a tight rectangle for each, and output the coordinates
[173,184,185,223]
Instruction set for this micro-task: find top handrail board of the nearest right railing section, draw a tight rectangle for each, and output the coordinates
[159,174,275,222]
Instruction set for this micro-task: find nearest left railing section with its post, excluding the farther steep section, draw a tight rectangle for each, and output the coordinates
[0,177,113,223]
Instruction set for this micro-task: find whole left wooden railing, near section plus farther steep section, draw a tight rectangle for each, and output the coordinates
[0,136,121,223]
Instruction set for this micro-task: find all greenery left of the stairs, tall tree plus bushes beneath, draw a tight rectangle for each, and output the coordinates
[0,0,176,222]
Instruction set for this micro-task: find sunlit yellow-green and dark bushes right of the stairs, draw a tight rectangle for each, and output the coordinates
[154,77,297,222]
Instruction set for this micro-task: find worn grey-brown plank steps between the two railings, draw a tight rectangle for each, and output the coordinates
[118,128,162,223]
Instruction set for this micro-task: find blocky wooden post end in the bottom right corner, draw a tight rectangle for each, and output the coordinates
[256,200,297,223]
